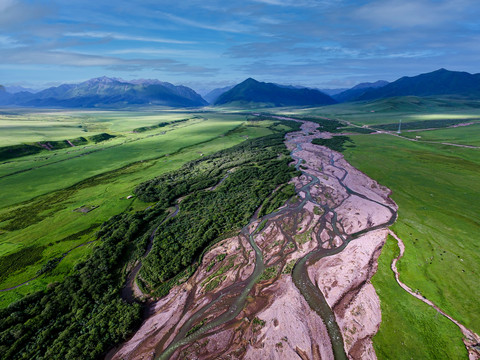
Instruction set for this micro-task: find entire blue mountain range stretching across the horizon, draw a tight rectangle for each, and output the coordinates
[0,69,480,108]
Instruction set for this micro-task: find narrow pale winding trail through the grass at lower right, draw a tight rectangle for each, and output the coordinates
[388,230,480,360]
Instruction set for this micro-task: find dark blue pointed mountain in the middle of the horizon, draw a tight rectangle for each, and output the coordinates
[215,78,336,106]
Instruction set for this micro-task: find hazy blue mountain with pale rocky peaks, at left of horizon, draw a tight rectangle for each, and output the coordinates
[0,77,207,108]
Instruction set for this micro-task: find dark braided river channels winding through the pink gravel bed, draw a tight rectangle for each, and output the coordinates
[112,118,397,360]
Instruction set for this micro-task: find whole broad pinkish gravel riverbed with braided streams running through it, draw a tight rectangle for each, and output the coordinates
[111,118,396,360]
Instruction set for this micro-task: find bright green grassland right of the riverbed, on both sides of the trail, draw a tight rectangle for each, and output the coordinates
[345,134,480,359]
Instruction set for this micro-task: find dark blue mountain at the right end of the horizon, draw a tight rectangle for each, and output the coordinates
[356,69,480,100]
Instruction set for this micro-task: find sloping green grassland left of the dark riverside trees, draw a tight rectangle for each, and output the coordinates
[0,112,285,306]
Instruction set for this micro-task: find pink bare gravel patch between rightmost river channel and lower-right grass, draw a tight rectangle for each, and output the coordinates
[308,230,387,359]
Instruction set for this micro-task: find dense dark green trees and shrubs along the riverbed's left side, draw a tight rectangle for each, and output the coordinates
[0,113,298,359]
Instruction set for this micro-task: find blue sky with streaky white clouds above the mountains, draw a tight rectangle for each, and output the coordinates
[0,0,480,92]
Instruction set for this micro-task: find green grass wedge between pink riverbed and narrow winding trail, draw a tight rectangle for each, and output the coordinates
[372,236,468,360]
